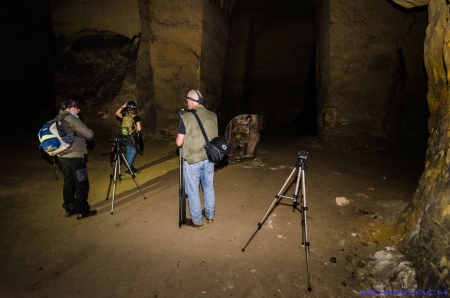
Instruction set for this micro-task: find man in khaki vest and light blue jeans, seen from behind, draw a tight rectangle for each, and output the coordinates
[175,90,218,230]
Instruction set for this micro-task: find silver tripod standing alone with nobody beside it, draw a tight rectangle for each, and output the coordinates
[242,151,312,291]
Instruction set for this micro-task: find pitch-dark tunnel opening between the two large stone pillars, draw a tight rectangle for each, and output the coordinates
[217,0,317,135]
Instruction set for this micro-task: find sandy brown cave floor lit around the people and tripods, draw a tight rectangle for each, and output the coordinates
[0,134,423,297]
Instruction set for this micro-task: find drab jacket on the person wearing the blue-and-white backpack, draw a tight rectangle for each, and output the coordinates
[58,111,94,158]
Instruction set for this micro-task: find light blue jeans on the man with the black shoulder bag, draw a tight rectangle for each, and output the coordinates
[183,159,216,225]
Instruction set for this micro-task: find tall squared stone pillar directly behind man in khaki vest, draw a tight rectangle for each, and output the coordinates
[142,0,228,136]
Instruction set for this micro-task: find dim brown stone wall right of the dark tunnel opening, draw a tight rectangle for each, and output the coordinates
[318,0,428,150]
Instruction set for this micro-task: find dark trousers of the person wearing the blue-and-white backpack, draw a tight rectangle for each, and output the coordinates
[58,157,91,213]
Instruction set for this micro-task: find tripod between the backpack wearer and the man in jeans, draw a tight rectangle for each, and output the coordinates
[106,136,147,214]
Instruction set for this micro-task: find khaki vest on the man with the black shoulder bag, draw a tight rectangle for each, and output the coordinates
[181,105,219,164]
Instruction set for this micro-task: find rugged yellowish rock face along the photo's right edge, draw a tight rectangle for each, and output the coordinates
[399,0,450,289]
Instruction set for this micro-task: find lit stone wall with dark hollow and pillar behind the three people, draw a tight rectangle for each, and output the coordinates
[51,0,230,136]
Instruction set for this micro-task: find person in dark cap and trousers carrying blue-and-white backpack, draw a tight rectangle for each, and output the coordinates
[57,100,97,219]
